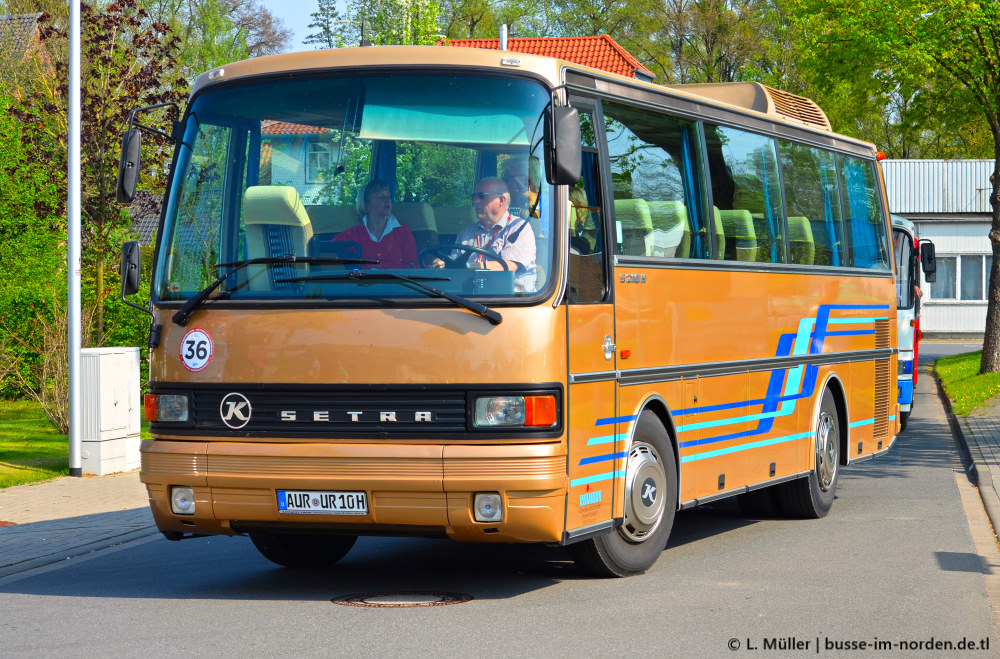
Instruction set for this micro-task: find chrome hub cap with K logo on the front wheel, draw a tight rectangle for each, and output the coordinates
[620,442,667,542]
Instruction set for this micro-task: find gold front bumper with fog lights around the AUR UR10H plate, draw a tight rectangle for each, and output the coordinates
[140,440,568,542]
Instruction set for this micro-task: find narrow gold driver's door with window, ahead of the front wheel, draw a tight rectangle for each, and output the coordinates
[564,107,621,541]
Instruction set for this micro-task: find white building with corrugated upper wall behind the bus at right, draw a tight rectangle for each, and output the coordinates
[882,160,993,337]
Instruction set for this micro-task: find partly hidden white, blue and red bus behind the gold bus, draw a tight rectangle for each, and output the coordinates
[889,215,937,432]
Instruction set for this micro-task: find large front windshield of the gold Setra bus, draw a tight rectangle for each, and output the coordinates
[153,72,556,305]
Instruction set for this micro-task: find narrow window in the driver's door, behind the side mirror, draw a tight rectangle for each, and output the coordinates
[566,112,608,304]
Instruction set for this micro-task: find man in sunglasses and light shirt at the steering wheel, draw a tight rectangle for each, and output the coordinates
[431,178,535,292]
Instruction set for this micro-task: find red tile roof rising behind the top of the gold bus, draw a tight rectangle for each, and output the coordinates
[437,34,654,78]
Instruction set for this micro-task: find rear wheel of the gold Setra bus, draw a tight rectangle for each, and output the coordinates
[778,389,840,519]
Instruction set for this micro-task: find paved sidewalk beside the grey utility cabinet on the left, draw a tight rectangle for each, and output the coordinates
[0,471,157,577]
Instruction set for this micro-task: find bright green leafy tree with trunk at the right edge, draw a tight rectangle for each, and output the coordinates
[793,0,1000,373]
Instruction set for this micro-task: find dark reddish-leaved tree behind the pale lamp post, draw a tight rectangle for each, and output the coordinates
[12,0,187,345]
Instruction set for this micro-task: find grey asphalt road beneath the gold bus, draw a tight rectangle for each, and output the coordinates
[0,368,1000,657]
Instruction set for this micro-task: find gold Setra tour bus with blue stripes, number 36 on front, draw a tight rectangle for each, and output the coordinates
[118,47,899,576]
